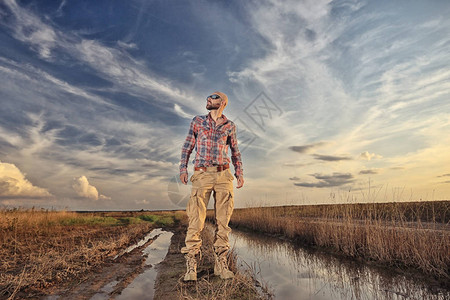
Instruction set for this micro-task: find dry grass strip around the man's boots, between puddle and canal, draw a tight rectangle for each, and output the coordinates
[178,225,270,300]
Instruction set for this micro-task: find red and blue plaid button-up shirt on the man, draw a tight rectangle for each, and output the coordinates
[180,113,244,177]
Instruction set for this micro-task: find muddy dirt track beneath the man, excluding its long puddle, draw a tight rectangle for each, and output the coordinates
[43,226,261,300]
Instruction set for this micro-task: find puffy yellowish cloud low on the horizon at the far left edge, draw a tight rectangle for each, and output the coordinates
[0,161,52,198]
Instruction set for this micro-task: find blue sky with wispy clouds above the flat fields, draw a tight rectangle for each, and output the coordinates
[0,0,450,210]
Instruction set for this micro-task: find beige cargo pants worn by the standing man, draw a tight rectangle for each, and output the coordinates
[181,167,234,254]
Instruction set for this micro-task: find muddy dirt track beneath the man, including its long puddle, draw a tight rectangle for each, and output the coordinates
[42,226,263,300]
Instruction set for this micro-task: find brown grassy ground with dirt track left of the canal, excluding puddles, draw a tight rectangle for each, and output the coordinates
[0,209,260,300]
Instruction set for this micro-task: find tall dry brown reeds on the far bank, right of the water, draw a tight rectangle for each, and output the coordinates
[214,201,450,283]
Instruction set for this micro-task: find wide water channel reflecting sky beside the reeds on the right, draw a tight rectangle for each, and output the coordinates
[230,230,450,300]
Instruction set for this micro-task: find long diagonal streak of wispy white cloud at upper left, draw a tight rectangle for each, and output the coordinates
[1,0,202,110]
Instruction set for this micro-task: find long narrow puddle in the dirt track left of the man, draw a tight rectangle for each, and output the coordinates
[91,228,173,300]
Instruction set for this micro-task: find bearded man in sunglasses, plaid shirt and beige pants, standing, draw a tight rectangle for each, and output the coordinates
[180,92,244,281]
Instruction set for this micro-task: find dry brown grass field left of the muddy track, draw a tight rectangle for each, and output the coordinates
[0,209,183,299]
